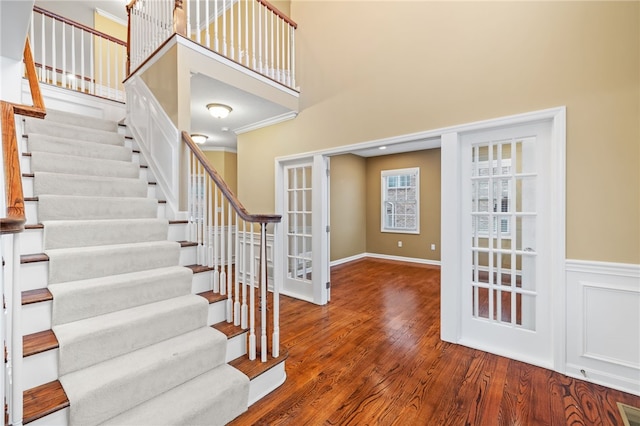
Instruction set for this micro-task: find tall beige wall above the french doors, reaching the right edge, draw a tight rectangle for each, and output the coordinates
[238,1,640,263]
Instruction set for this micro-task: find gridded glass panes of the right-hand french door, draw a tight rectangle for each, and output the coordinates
[469,138,537,330]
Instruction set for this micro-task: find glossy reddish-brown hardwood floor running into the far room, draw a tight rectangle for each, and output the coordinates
[231,259,640,426]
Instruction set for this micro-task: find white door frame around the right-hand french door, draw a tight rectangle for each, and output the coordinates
[440,107,566,372]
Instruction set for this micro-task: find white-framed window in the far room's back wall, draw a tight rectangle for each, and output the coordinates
[381,167,420,234]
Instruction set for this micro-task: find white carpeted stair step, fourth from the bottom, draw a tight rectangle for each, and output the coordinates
[48,266,193,326]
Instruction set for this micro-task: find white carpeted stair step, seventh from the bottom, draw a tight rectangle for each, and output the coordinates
[38,195,158,222]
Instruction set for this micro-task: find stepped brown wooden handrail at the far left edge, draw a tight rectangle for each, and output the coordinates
[0,39,46,234]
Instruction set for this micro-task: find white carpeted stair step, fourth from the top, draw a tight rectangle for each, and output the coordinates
[31,151,140,178]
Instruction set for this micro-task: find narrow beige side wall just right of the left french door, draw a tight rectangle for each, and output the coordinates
[330,154,368,261]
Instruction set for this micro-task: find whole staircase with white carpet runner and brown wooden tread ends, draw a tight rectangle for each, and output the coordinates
[21,110,286,426]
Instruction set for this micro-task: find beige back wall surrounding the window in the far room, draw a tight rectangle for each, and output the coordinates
[364,149,440,261]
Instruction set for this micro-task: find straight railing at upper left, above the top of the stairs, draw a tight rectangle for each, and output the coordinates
[29,6,127,102]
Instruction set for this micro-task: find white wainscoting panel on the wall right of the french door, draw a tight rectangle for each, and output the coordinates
[566,260,640,395]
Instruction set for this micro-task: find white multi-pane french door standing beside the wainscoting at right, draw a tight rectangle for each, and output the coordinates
[460,122,554,367]
